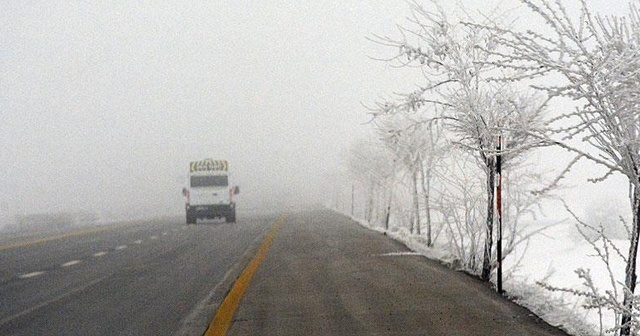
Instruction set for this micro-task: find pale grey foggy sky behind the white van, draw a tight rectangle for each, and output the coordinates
[0,0,626,224]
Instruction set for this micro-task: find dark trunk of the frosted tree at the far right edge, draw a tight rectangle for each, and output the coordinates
[620,183,640,336]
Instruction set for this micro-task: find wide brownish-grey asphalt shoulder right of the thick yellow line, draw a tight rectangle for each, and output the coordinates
[229,211,565,336]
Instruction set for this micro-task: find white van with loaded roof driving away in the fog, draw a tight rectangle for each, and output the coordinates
[182,159,240,225]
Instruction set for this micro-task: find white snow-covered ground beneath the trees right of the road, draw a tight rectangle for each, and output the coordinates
[354,210,628,336]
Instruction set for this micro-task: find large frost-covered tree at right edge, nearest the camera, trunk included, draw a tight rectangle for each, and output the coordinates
[478,0,640,335]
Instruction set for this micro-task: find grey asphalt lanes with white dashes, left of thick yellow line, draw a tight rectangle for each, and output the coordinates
[0,216,276,335]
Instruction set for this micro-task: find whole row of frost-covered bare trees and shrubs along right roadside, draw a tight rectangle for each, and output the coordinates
[342,0,640,336]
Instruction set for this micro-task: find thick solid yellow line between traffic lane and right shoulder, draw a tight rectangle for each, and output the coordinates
[204,217,285,336]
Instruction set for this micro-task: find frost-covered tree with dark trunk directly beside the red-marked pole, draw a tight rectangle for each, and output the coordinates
[373,1,544,281]
